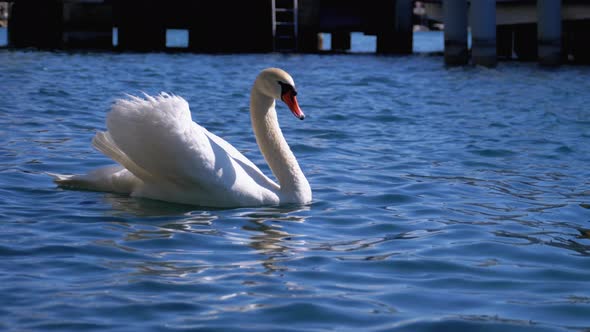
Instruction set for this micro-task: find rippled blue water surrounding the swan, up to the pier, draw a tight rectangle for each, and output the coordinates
[0,29,590,332]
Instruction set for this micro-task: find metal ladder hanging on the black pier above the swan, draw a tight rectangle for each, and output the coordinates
[272,0,299,52]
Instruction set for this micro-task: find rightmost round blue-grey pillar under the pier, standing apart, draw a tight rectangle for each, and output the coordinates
[537,0,561,66]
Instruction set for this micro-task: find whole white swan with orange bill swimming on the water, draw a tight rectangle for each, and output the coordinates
[51,68,312,207]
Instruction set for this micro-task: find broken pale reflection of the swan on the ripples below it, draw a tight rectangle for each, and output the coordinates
[99,194,311,277]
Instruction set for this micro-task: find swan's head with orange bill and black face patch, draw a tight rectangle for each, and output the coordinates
[254,68,305,120]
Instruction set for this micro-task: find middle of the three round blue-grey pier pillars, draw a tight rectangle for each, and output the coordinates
[470,0,498,67]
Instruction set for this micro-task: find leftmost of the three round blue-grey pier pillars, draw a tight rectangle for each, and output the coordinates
[443,0,469,66]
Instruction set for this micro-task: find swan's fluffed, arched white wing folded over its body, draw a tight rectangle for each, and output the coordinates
[107,93,272,190]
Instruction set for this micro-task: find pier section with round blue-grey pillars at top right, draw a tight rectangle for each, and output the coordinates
[423,0,590,67]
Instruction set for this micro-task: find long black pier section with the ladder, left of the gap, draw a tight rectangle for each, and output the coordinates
[0,0,413,54]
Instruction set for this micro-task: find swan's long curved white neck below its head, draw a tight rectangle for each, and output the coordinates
[250,88,311,202]
